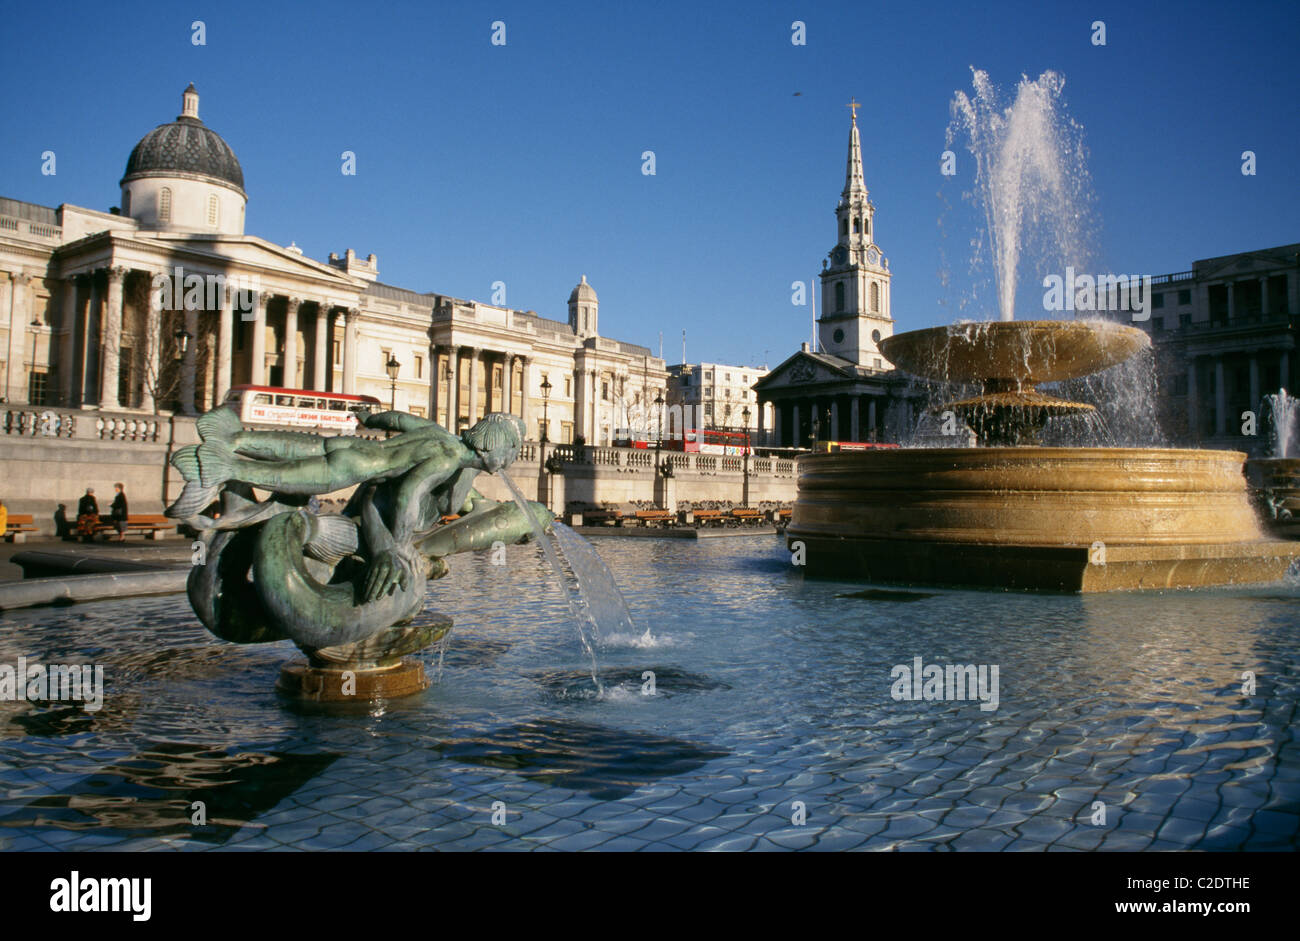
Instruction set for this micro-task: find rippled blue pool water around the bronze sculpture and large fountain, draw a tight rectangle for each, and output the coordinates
[0,537,1300,850]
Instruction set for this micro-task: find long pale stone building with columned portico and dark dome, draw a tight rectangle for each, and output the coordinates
[0,84,667,445]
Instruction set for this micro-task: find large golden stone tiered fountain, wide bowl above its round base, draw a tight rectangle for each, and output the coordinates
[787,321,1300,591]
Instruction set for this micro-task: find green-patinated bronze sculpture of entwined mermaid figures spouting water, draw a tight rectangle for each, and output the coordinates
[166,408,554,665]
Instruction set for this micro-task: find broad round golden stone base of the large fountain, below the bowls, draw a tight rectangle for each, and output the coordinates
[787,447,1300,591]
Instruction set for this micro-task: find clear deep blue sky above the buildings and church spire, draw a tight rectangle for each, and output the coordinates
[0,0,1300,365]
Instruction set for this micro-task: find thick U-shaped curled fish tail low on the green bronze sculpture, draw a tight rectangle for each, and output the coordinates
[254,512,426,647]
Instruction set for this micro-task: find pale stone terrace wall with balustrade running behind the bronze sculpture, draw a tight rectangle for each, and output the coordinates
[0,407,797,533]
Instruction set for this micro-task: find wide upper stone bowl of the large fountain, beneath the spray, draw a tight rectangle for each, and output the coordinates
[880,320,1151,386]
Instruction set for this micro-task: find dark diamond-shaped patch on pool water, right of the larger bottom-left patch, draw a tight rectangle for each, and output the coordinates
[434,719,727,801]
